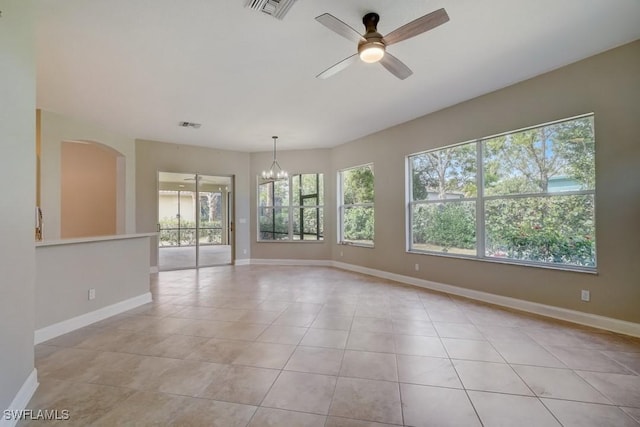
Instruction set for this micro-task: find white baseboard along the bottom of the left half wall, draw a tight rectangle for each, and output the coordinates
[34,292,151,344]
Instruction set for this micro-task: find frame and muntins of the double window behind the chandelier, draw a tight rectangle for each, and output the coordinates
[256,172,326,243]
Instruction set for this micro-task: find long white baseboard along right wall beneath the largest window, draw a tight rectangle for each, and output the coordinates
[332,261,640,337]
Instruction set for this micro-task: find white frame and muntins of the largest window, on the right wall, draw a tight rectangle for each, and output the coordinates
[405,113,598,274]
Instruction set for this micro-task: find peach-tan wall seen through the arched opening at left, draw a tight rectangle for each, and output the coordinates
[60,141,118,238]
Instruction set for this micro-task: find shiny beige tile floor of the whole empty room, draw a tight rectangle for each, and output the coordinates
[21,266,640,427]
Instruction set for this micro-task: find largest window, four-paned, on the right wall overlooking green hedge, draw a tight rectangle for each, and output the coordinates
[408,115,596,270]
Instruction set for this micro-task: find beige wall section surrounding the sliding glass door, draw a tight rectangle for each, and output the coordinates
[136,140,251,266]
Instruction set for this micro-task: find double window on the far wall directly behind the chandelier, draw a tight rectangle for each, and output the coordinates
[258,174,324,241]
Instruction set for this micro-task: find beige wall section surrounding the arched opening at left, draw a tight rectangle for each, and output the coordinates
[40,111,136,240]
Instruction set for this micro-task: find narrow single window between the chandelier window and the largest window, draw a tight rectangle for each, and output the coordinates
[338,164,374,246]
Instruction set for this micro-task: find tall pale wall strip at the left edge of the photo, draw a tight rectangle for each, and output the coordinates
[0,0,36,412]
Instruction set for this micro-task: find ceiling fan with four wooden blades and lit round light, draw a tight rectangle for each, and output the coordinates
[316,9,449,80]
